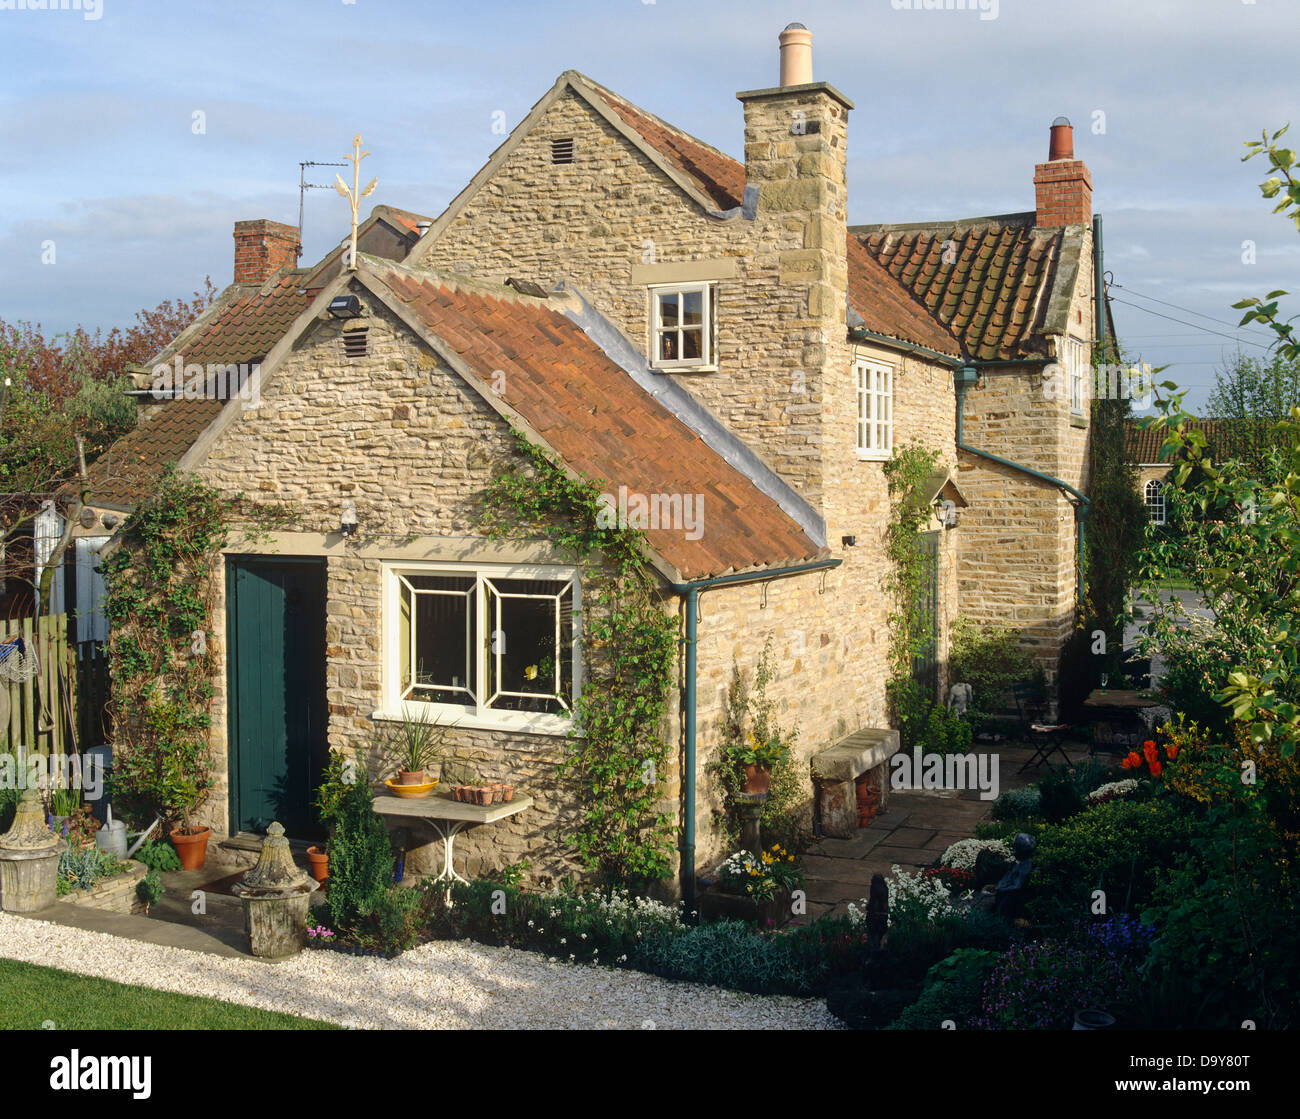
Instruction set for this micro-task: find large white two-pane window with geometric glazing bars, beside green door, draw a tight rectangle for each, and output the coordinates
[376,564,581,733]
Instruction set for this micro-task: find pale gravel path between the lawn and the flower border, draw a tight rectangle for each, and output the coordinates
[0,914,839,1029]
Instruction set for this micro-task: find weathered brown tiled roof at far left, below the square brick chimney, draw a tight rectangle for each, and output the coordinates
[87,269,307,508]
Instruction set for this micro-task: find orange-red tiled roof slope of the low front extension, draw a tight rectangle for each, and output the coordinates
[378,269,824,578]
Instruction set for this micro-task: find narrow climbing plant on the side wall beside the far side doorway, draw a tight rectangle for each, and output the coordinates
[884,441,939,750]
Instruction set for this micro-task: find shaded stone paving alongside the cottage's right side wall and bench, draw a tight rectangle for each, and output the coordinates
[796,741,1088,924]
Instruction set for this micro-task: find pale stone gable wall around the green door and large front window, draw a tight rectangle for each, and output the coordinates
[189,294,621,876]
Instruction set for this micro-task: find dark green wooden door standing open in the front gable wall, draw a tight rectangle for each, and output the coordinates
[226,556,328,836]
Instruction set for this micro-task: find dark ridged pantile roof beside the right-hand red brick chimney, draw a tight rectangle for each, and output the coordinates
[853,213,1066,361]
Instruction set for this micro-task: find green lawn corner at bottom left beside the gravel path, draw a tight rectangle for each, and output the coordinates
[0,959,339,1029]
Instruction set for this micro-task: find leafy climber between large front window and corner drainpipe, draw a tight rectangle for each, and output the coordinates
[481,431,677,882]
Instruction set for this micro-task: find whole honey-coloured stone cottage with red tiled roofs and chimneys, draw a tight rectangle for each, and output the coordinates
[81,25,1097,893]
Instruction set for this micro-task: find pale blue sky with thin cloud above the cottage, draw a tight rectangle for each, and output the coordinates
[0,0,1300,405]
